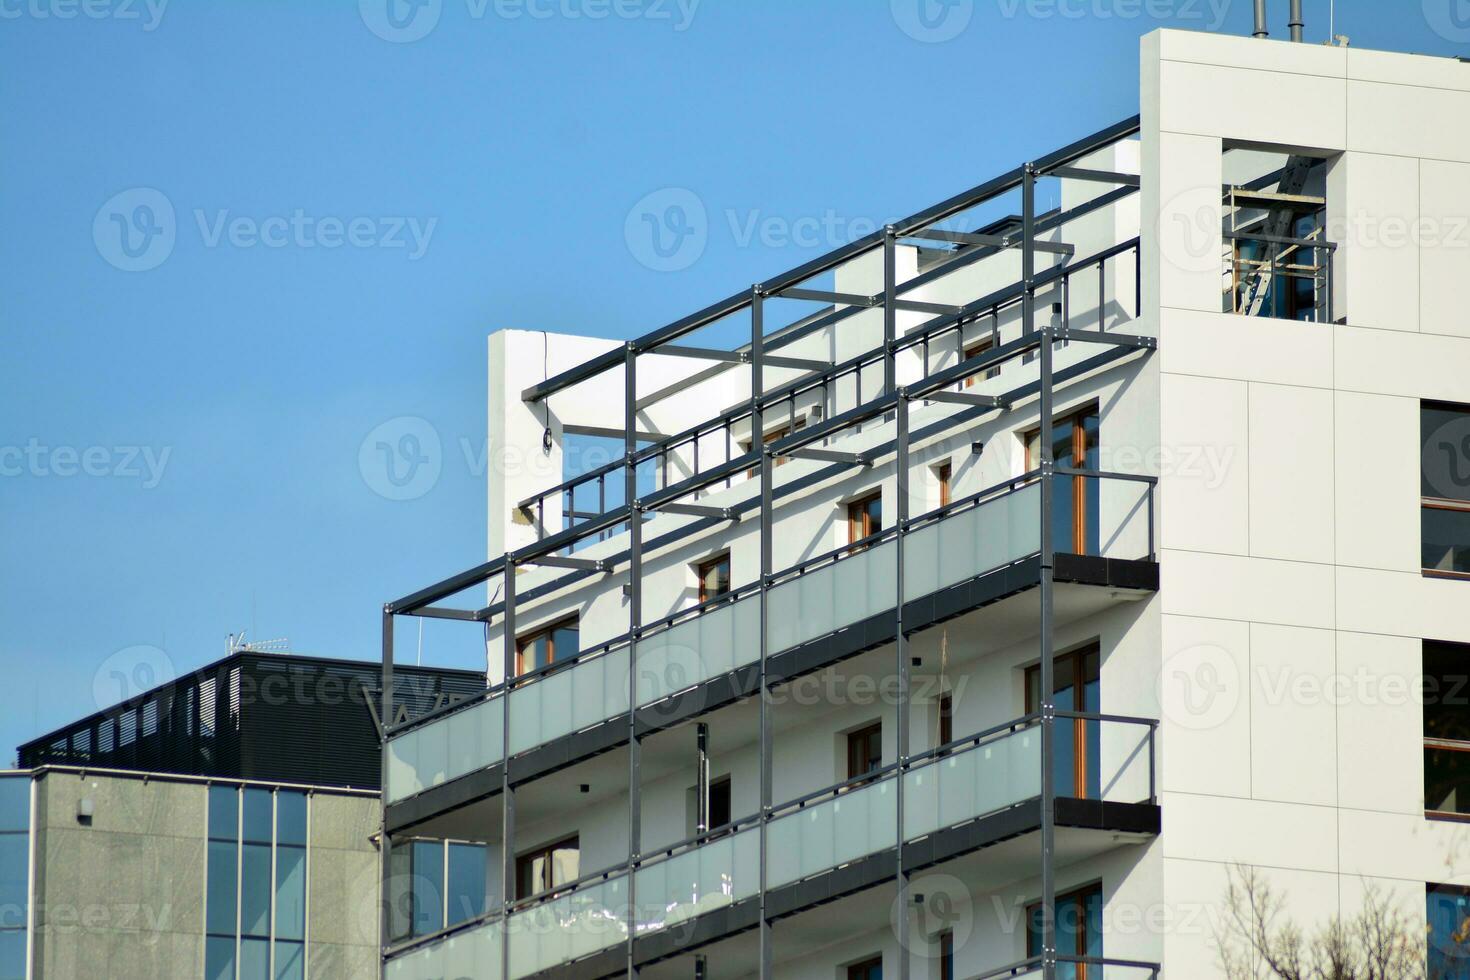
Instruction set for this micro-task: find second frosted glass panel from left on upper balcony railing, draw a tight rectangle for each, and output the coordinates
[510,646,628,755]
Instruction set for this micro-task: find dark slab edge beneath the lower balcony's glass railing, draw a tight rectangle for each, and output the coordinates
[520,796,1161,980]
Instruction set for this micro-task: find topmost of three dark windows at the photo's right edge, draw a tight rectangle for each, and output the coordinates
[1419,401,1470,577]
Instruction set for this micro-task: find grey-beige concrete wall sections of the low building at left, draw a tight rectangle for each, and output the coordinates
[32,770,379,980]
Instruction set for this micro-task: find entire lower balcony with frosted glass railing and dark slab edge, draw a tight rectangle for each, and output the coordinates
[387,714,1158,980]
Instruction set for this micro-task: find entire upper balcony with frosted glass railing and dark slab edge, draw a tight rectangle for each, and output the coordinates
[387,467,1157,830]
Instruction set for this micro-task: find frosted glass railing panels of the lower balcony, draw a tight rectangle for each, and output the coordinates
[388,713,1155,980]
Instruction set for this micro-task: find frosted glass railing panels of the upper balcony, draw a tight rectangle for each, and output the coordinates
[387,470,1154,804]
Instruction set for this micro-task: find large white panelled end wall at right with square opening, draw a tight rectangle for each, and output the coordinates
[1142,31,1470,977]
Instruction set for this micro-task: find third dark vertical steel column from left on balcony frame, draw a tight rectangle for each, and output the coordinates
[623,342,642,980]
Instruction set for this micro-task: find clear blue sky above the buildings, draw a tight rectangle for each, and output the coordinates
[0,0,1470,763]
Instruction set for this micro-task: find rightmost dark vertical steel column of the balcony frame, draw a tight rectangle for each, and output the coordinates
[1022,163,1057,980]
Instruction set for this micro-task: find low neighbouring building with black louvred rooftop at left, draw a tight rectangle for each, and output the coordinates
[0,652,487,980]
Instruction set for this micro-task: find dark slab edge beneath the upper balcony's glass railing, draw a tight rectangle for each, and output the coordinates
[385,554,1158,833]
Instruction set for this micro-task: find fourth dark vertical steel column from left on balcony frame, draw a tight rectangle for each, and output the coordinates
[750,285,775,980]
